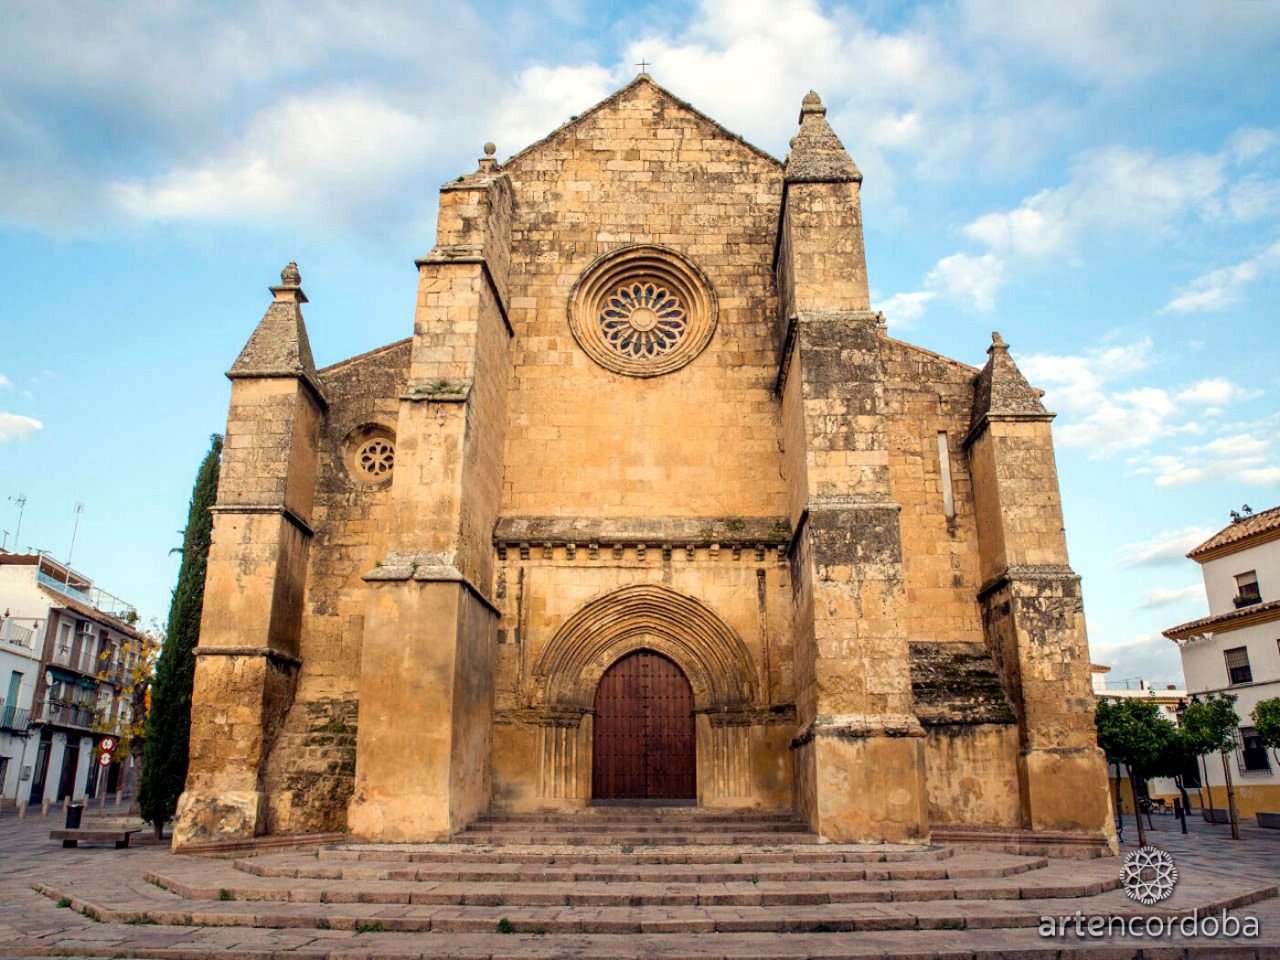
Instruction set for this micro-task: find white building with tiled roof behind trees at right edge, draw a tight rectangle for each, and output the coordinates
[1165,507,1280,817]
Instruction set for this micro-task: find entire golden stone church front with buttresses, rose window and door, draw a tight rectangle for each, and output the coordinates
[174,74,1111,846]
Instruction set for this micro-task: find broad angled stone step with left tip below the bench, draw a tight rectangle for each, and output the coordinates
[36,864,1276,936]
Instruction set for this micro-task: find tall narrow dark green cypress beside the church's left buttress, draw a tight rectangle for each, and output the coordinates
[138,434,223,837]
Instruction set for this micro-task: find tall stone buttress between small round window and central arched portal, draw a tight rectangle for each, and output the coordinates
[348,144,512,840]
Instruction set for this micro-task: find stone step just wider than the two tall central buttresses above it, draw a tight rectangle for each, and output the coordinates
[325,842,955,865]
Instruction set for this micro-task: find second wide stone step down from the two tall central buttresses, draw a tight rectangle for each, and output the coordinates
[233,854,1048,884]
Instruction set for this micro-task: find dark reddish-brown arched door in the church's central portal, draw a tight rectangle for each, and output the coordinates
[591,650,696,800]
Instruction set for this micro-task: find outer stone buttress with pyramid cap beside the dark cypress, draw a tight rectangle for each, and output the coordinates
[173,264,326,847]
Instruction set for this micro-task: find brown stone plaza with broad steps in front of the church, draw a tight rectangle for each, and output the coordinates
[0,810,1280,960]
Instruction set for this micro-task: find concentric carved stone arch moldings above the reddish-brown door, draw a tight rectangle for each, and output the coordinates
[534,584,755,712]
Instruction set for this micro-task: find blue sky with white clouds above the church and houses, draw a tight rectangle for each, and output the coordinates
[0,0,1280,680]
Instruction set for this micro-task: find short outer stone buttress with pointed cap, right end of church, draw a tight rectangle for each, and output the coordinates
[965,333,1114,837]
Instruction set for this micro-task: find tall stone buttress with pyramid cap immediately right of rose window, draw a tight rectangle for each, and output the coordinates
[776,93,929,841]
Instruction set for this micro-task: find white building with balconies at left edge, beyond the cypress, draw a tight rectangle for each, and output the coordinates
[0,552,151,804]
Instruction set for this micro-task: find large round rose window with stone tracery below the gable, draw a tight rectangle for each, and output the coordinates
[568,246,717,376]
